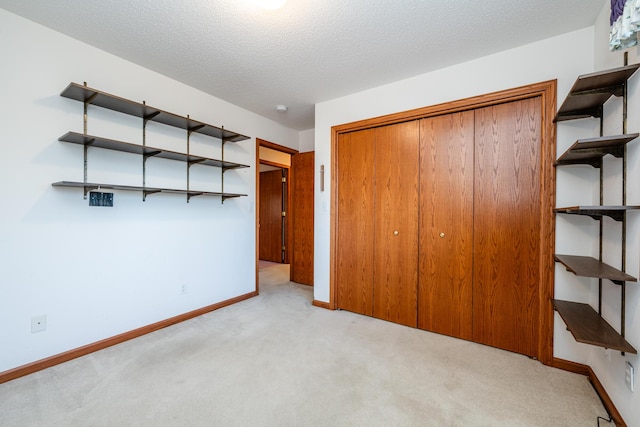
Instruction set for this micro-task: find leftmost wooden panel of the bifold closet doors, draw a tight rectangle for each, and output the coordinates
[336,130,375,316]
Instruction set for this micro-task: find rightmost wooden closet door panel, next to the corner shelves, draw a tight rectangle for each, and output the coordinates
[473,97,541,356]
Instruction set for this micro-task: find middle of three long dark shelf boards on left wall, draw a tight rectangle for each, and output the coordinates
[58,132,249,170]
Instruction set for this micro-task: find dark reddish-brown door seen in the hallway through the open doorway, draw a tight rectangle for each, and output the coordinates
[259,170,283,262]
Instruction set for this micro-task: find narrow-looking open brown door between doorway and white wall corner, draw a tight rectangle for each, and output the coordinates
[290,152,314,285]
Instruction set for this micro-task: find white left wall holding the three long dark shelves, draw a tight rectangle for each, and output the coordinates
[0,9,299,372]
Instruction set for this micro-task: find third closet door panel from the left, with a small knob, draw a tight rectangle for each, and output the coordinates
[418,111,474,340]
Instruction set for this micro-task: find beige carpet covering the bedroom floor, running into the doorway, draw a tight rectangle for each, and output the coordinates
[0,265,609,427]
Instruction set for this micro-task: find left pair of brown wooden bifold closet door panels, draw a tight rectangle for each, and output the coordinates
[336,121,419,326]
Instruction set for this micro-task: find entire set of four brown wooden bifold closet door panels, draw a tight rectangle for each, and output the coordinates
[335,96,544,357]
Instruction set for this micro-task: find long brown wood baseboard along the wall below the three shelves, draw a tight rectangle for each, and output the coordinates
[0,291,258,384]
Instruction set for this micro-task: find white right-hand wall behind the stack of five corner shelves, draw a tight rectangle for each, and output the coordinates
[589,3,640,426]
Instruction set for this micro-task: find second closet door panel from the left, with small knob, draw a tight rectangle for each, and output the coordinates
[369,121,419,327]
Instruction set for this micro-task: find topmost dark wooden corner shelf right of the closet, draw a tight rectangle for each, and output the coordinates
[553,64,640,122]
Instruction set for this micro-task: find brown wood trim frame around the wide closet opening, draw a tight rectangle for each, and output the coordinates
[328,80,557,365]
